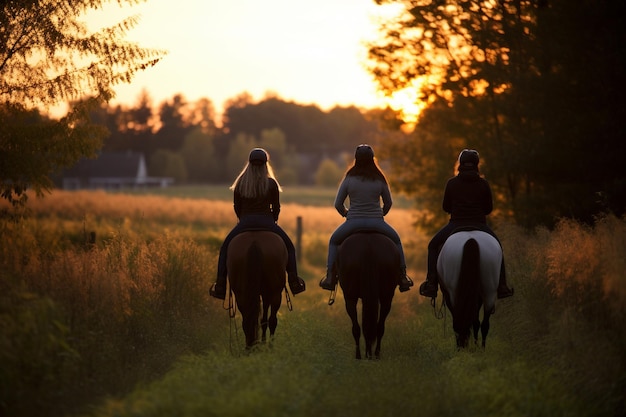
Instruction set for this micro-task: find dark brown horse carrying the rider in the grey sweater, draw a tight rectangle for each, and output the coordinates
[337,231,400,359]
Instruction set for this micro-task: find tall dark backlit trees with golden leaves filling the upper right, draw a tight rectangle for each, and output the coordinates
[370,0,626,225]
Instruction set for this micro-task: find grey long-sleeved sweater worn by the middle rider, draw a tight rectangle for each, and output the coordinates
[335,176,393,219]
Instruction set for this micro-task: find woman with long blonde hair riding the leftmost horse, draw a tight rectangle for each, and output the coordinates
[209,148,306,300]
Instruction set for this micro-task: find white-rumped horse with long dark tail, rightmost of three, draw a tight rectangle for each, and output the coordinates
[437,230,502,349]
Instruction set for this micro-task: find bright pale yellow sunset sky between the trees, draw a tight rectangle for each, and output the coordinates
[88,0,414,122]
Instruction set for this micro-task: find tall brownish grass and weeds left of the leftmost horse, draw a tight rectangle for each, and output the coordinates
[0,221,218,416]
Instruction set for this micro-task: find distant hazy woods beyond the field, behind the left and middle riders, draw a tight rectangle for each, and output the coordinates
[91,91,381,185]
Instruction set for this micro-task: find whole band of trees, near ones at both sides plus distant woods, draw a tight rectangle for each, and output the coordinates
[0,0,626,227]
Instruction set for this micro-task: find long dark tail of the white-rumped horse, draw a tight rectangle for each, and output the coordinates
[455,239,480,328]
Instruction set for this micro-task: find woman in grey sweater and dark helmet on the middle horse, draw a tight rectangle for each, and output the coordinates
[320,145,413,292]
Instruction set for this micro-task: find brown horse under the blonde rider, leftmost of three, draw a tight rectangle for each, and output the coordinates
[226,230,287,349]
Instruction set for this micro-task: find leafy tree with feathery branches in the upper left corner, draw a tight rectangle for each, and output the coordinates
[0,0,164,204]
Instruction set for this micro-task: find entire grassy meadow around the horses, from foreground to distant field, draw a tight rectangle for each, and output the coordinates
[0,187,626,417]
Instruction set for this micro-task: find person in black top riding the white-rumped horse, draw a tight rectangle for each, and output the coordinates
[420,149,513,298]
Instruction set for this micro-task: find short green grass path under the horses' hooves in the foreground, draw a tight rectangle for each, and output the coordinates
[81,291,582,417]
